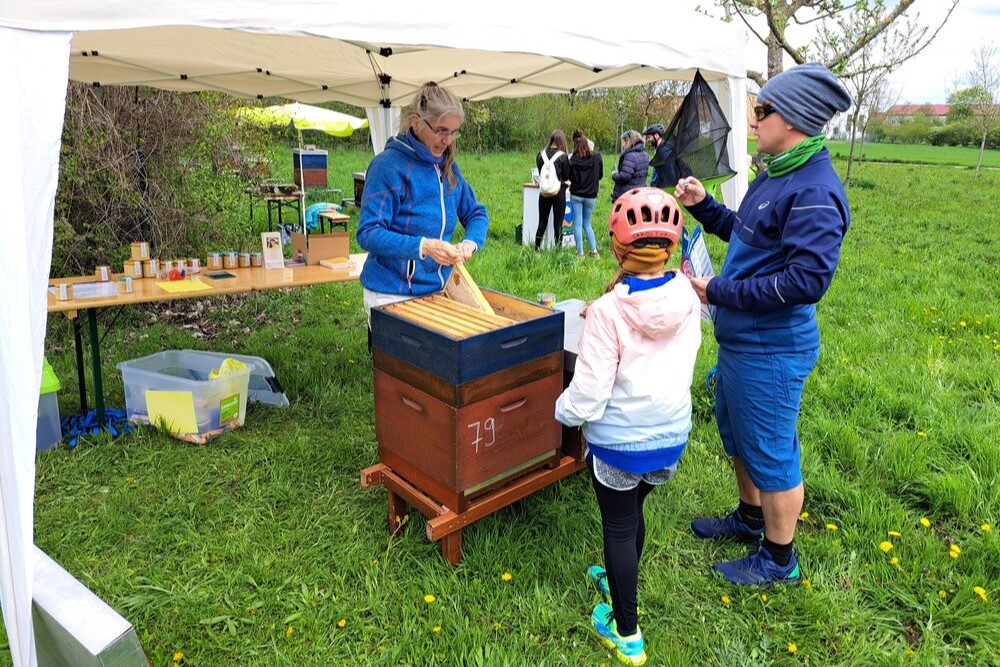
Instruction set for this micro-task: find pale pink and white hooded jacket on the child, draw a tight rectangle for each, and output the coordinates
[556,272,701,449]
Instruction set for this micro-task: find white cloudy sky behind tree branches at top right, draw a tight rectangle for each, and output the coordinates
[688,0,1000,104]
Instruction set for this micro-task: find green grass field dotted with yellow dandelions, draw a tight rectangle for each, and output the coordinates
[19,147,1000,667]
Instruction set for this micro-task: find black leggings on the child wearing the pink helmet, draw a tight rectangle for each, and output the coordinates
[587,454,656,637]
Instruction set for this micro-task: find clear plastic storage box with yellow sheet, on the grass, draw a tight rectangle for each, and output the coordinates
[118,350,250,443]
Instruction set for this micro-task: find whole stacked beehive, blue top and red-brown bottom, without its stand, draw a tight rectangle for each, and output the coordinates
[372,290,564,511]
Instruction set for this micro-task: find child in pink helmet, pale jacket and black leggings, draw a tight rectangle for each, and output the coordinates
[556,187,701,665]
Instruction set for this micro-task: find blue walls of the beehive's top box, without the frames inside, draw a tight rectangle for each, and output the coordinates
[371,289,564,386]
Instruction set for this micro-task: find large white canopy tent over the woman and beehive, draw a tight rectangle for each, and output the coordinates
[0,0,747,667]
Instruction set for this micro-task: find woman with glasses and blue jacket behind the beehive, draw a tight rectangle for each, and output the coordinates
[357,82,489,320]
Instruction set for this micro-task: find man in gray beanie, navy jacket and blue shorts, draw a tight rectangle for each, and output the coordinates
[674,63,851,587]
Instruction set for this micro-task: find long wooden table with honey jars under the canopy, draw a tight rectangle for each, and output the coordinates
[48,253,368,424]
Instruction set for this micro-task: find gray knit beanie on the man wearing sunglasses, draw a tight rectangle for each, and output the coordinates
[757,63,854,137]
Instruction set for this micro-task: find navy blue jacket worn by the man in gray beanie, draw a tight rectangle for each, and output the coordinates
[689,148,851,353]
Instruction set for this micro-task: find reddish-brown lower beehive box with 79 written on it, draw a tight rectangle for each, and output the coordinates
[375,368,563,511]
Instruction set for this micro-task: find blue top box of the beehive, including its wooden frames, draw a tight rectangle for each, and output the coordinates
[371,289,564,384]
